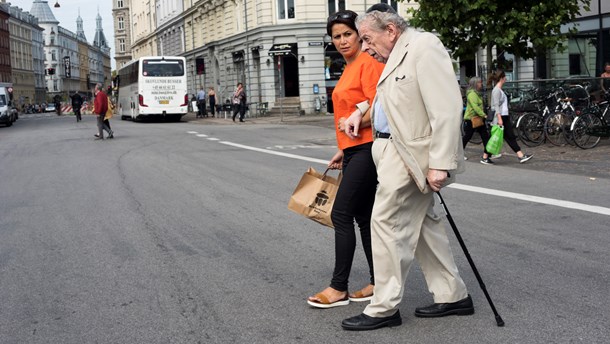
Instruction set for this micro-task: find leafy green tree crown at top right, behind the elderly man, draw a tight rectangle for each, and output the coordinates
[401,0,591,77]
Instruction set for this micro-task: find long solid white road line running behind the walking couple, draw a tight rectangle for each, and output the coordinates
[216,139,610,215]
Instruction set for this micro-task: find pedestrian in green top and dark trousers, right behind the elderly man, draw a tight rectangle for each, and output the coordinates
[462,77,494,165]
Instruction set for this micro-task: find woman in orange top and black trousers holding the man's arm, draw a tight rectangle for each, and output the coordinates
[307,11,384,308]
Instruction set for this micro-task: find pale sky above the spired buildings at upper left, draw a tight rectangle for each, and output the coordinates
[6,0,115,69]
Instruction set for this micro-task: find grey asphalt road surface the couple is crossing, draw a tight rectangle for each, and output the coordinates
[0,116,610,343]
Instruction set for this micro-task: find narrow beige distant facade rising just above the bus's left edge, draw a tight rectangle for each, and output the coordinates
[112,0,132,69]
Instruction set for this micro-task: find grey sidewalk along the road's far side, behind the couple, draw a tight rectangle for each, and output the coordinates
[183,113,610,178]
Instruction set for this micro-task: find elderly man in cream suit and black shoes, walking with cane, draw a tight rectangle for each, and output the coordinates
[342,5,474,331]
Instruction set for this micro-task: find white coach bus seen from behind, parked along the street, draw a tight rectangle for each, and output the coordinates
[117,56,188,121]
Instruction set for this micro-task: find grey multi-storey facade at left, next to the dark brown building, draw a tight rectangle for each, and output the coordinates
[8,6,44,107]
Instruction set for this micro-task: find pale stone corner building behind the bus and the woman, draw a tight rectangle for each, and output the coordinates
[132,0,413,112]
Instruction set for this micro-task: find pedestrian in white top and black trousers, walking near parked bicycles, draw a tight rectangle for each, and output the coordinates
[487,70,533,164]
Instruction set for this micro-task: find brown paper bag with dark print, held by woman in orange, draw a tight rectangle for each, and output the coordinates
[288,167,342,228]
